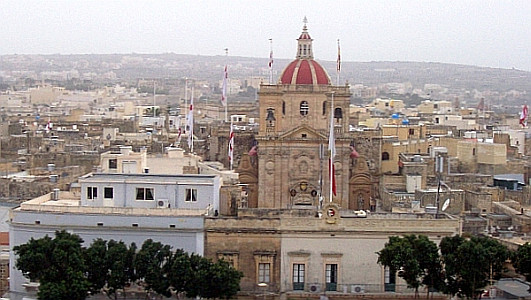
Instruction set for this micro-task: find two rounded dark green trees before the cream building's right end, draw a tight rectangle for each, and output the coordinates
[377,235,512,299]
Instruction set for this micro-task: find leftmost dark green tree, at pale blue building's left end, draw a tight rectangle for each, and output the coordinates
[13,231,90,300]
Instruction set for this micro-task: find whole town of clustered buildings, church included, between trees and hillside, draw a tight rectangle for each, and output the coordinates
[0,20,531,299]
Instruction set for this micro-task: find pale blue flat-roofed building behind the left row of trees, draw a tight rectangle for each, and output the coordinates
[9,174,221,299]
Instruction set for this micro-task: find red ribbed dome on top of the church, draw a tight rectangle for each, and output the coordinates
[280,59,330,85]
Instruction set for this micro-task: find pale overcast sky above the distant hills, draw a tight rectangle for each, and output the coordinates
[0,0,531,71]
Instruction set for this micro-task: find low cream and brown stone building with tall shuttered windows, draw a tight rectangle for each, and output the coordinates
[205,211,460,297]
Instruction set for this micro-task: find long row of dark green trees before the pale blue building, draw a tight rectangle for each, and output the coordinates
[14,231,243,300]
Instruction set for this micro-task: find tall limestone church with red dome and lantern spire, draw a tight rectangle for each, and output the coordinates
[238,19,372,209]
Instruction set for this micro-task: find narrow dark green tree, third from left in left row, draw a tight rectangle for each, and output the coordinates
[134,239,172,297]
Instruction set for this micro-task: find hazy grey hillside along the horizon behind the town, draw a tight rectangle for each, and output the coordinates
[0,53,531,92]
